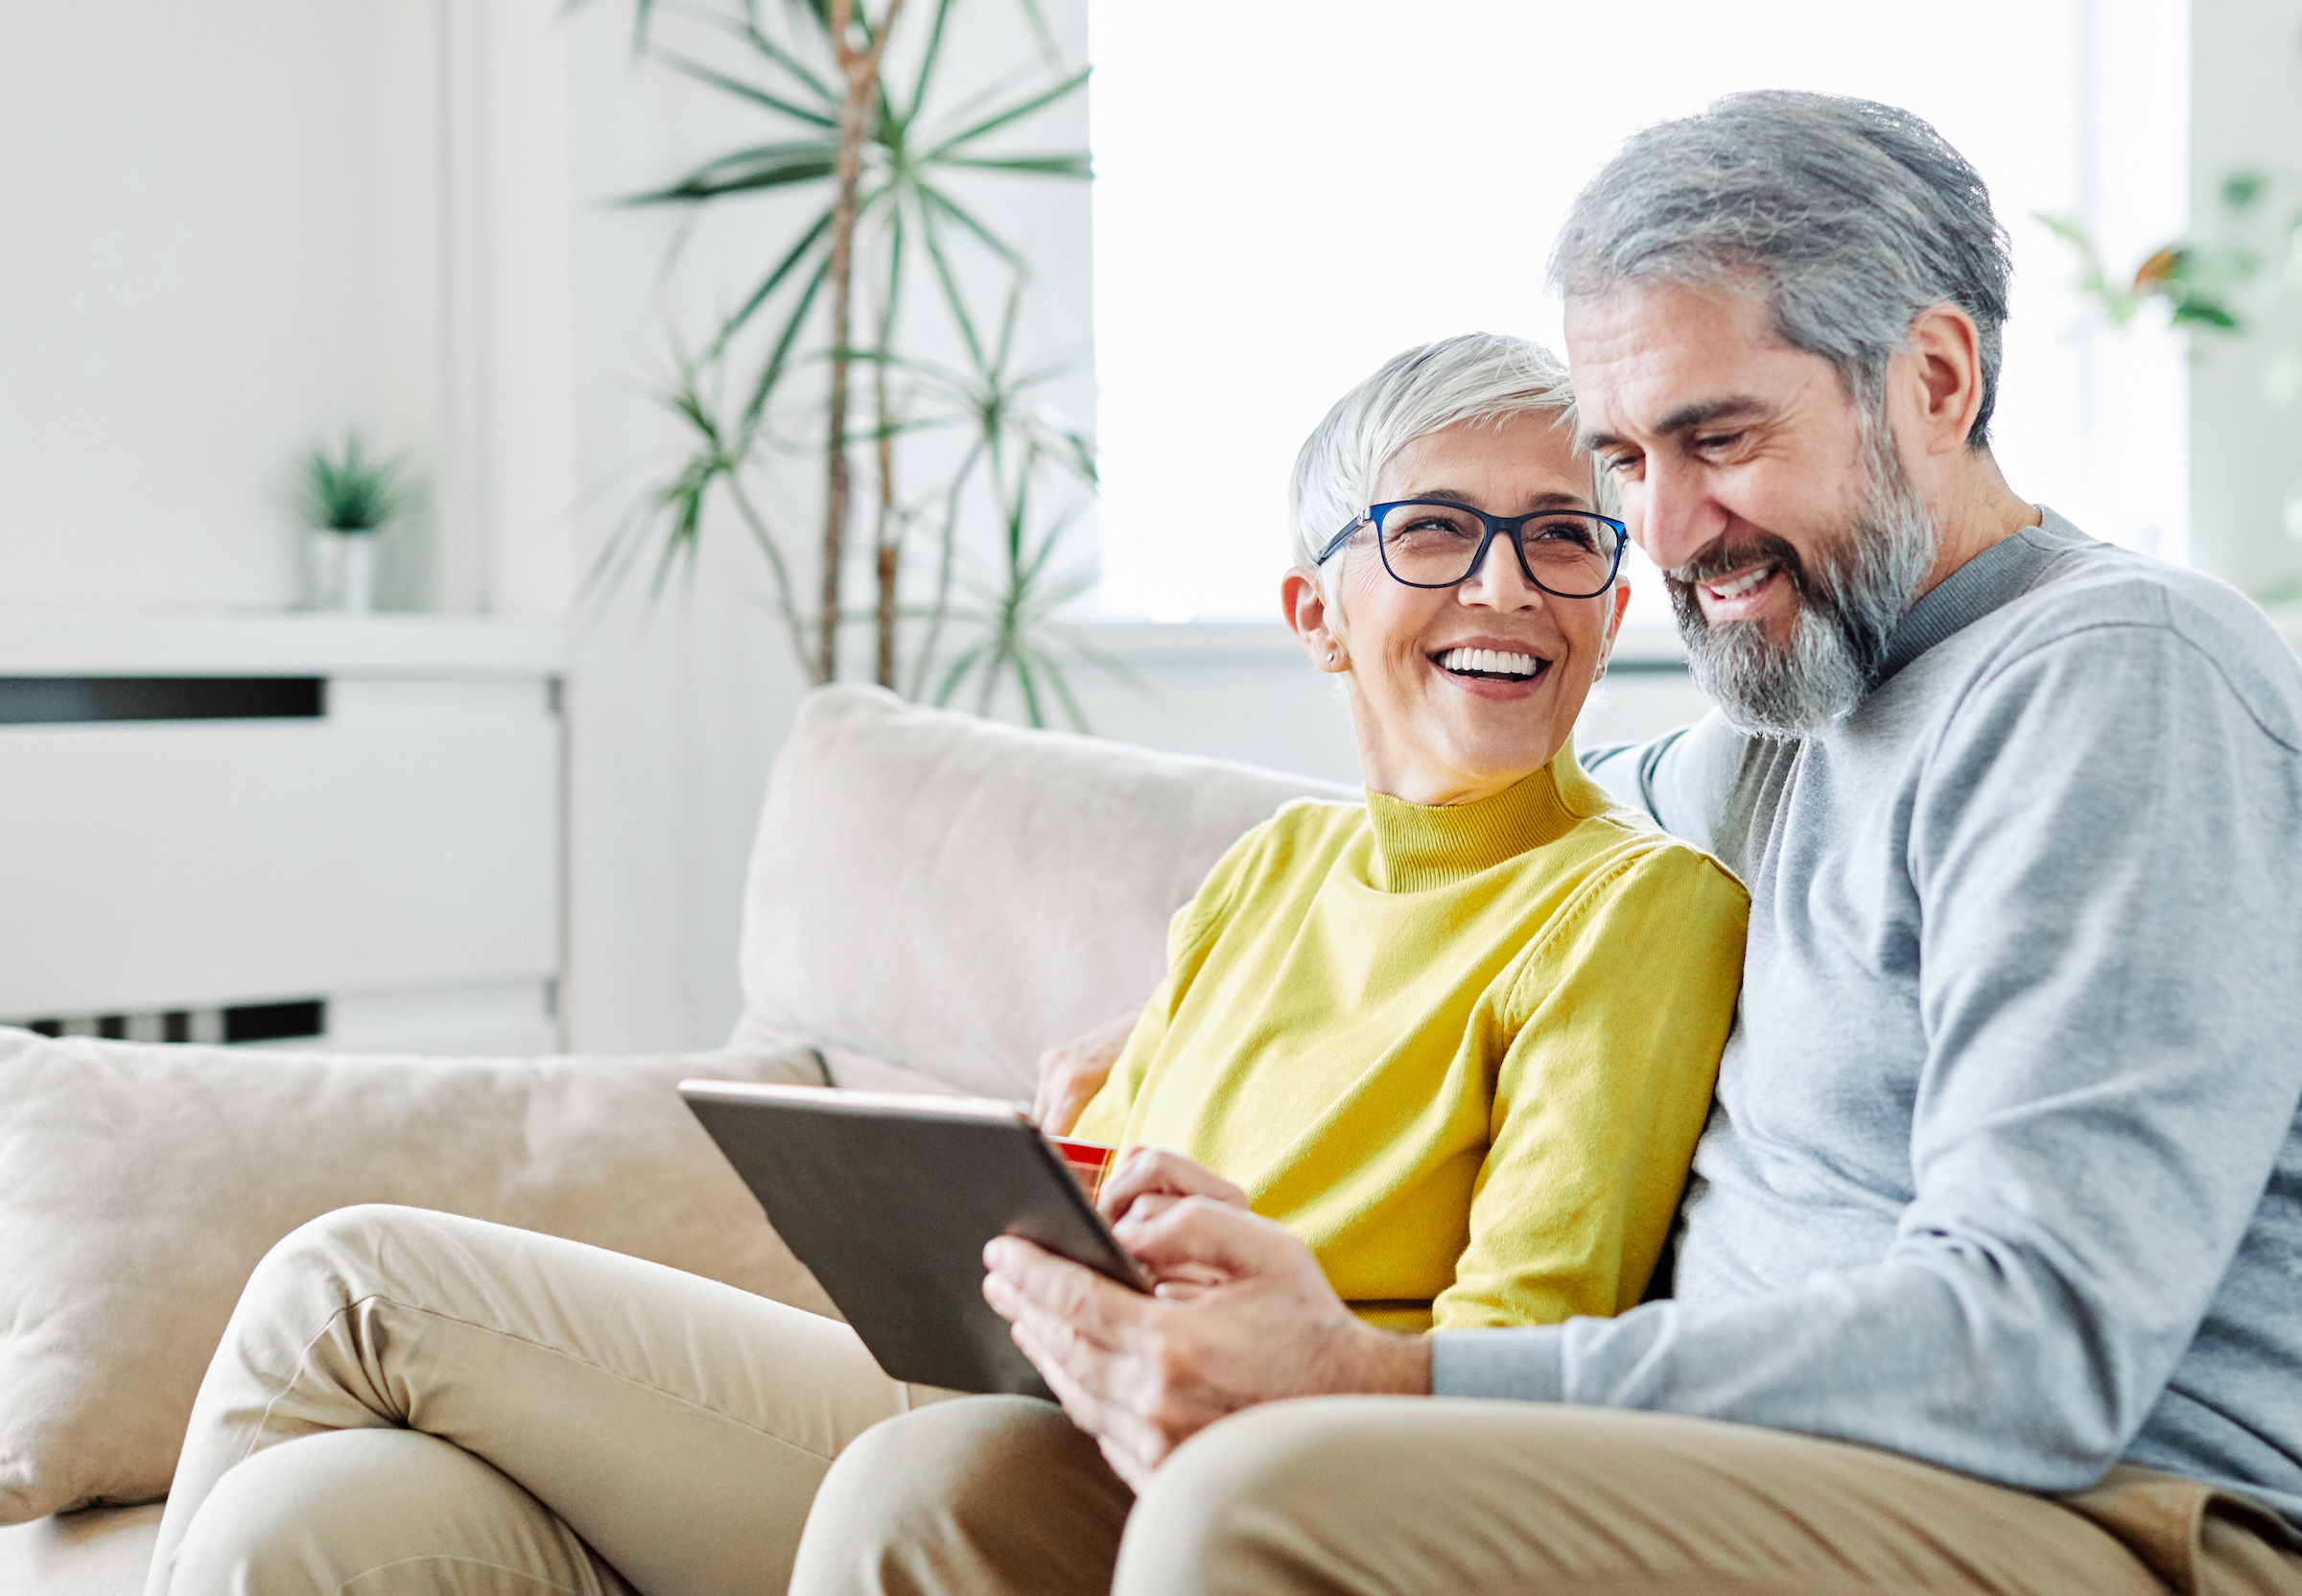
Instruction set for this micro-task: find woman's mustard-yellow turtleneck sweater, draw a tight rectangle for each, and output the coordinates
[1072,746,1750,1328]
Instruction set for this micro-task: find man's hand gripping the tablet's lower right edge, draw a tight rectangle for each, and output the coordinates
[983,1165,1429,1490]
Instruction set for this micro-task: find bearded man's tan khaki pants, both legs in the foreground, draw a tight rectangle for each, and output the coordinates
[792,1396,2302,1596]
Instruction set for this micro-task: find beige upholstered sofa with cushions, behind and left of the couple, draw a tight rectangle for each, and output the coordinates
[0,689,1356,1596]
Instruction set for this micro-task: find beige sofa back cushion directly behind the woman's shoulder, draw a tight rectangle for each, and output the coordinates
[730,687,1360,1098]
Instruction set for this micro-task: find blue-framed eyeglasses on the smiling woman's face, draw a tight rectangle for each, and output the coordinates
[1312,500,1628,598]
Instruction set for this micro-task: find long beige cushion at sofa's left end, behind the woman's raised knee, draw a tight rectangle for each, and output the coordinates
[0,1029,829,1525]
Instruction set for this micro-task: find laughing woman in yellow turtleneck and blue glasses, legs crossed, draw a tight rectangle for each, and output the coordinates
[150,337,1748,1596]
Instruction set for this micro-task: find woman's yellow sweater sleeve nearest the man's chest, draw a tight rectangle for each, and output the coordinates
[1432,843,1750,1328]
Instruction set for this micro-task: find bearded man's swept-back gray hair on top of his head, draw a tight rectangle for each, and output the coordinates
[1549,90,2012,449]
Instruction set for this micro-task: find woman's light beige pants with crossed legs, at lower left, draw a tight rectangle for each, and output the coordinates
[150,1207,949,1596]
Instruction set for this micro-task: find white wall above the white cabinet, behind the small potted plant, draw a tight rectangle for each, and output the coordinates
[0,0,571,613]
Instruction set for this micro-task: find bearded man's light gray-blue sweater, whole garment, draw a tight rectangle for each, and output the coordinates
[1432,511,2302,1522]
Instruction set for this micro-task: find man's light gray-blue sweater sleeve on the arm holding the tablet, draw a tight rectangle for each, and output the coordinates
[1432,624,2302,1490]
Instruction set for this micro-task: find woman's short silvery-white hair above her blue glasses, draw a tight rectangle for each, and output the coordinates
[1287,332,1605,564]
